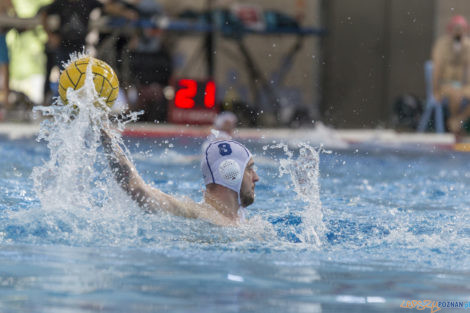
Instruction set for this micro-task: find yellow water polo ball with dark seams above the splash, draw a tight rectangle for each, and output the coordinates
[59,57,119,107]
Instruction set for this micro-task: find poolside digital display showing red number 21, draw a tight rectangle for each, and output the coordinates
[168,79,219,124]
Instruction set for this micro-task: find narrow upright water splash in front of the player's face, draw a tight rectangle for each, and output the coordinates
[271,143,325,246]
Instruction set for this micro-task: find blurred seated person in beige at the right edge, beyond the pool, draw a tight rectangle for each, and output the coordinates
[432,15,470,135]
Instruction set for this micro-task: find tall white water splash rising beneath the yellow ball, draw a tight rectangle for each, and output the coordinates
[24,54,149,244]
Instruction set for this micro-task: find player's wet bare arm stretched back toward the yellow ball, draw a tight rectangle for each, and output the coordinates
[101,130,197,218]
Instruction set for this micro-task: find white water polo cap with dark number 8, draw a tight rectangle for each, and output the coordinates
[201,140,251,203]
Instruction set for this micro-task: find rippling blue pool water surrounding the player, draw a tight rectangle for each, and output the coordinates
[0,132,470,312]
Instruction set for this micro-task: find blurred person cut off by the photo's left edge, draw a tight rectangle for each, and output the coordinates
[0,0,16,119]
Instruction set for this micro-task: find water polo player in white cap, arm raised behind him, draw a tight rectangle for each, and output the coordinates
[101,130,259,226]
